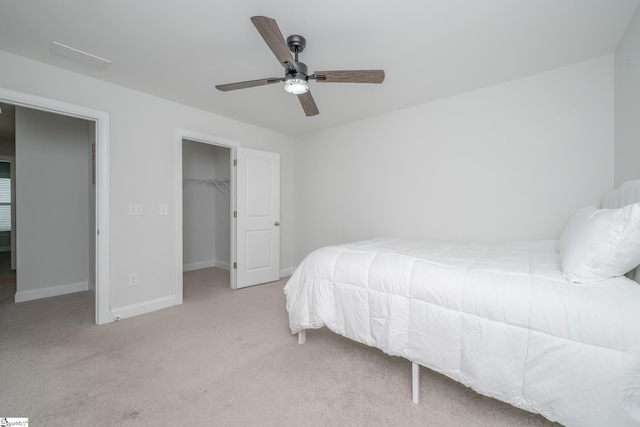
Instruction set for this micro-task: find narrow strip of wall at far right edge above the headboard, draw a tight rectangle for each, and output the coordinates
[615,5,640,186]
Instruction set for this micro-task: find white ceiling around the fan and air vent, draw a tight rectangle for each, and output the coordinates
[0,0,640,135]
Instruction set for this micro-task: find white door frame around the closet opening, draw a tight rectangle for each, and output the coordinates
[173,128,240,305]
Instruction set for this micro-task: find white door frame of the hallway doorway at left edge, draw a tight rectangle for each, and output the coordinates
[0,87,114,325]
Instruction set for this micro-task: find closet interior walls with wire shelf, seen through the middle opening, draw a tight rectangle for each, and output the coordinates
[182,139,231,271]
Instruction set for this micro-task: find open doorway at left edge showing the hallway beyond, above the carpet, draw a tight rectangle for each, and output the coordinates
[0,103,96,308]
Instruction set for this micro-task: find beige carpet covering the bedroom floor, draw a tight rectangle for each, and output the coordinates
[0,269,553,427]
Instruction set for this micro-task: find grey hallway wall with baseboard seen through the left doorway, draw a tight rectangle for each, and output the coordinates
[16,108,90,301]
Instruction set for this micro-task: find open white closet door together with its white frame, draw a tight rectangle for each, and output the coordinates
[174,129,280,304]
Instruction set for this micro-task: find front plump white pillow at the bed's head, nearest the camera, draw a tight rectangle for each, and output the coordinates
[560,203,640,283]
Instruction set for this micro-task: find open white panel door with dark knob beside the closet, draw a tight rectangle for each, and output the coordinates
[235,147,280,288]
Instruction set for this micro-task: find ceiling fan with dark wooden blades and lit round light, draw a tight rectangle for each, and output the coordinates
[216,16,384,116]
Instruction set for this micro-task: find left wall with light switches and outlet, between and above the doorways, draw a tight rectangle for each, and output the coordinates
[0,52,294,318]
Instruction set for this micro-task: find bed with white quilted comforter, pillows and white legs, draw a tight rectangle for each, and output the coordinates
[284,181,640,426]
